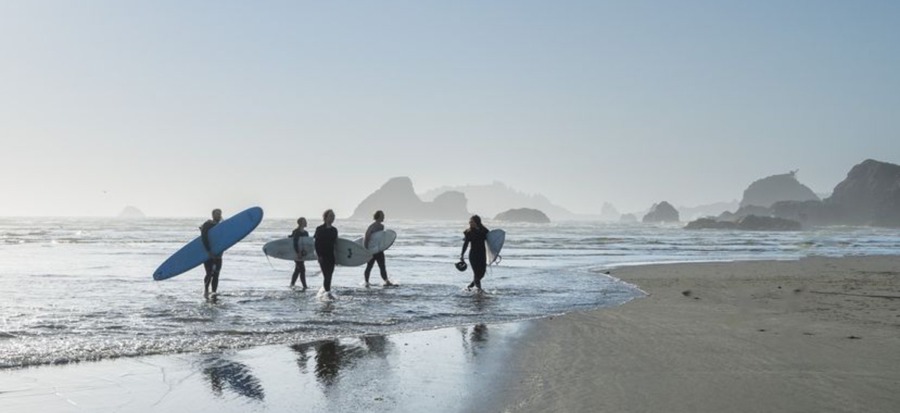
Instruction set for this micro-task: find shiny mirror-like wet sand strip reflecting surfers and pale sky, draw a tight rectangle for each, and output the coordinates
[0,323,524,413]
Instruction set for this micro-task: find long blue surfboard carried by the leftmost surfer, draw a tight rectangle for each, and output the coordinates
[153,207,263,281]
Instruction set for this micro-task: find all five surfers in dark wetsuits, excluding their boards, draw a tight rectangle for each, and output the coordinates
[200,208,489,298]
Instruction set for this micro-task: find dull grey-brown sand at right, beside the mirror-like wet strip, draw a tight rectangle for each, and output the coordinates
[490,256,900,412]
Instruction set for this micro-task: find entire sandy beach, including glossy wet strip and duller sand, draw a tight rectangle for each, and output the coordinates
[0,257,900,412]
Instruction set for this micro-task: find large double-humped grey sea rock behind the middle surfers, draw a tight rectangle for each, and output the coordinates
[350,177,469,220]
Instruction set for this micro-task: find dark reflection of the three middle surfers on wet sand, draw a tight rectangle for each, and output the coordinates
[291,335,389,388]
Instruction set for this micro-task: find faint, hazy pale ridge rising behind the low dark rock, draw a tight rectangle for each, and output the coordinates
[422,182,578,220]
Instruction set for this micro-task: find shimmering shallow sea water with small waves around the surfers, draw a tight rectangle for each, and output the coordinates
[0,218,900,368]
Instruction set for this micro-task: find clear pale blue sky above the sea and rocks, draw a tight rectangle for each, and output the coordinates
[0,0,900,218]
